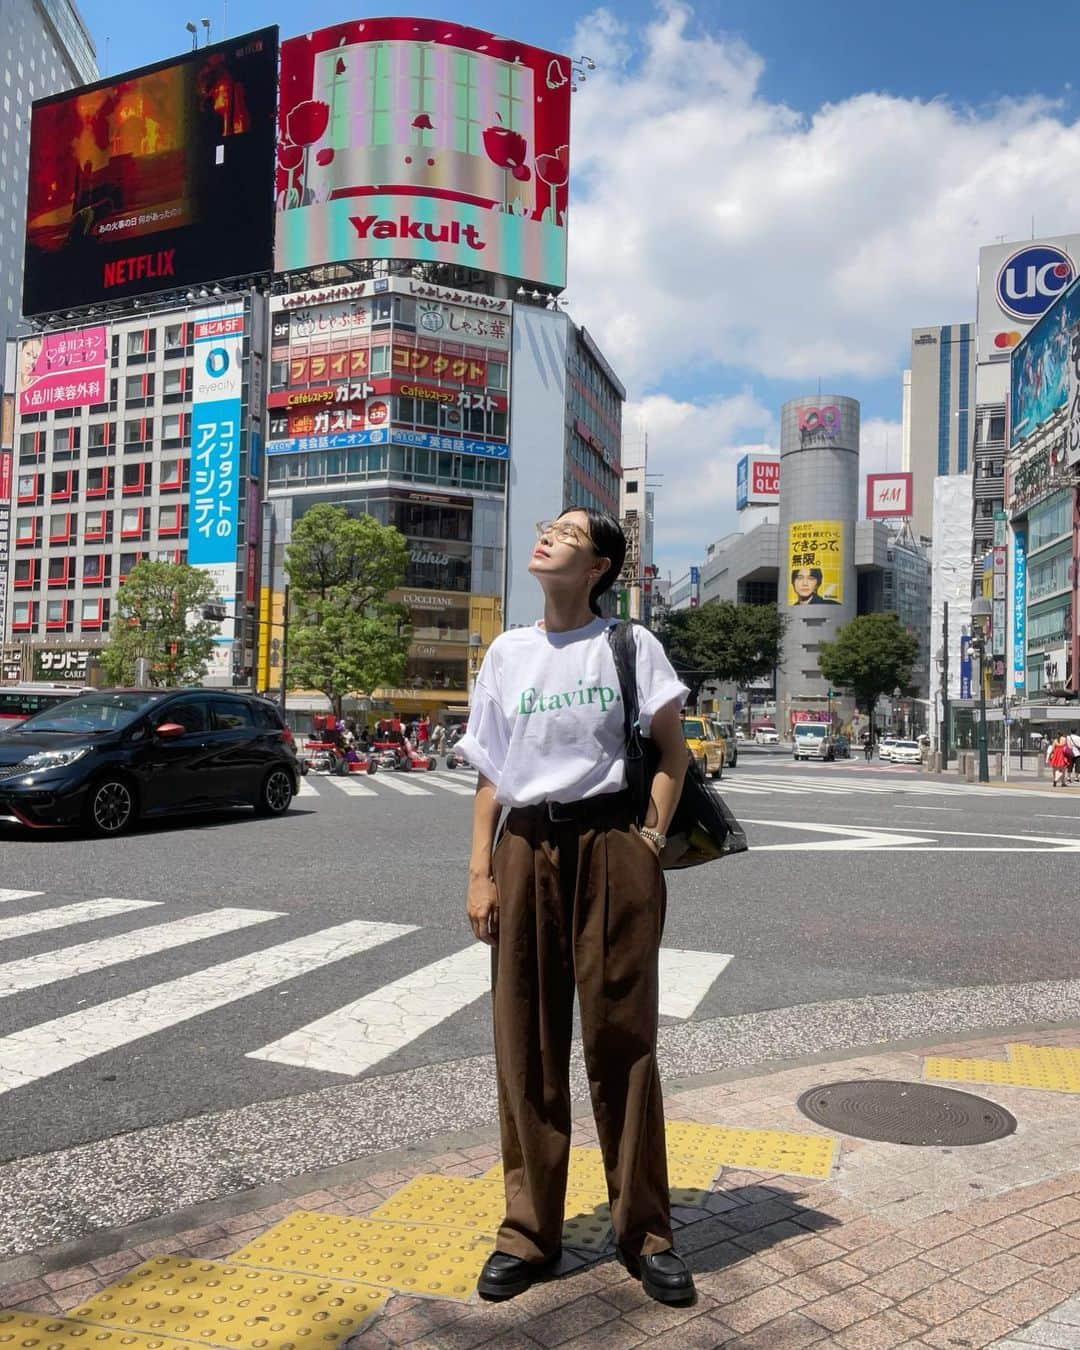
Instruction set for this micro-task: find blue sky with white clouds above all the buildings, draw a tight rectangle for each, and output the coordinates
[78,0,1080,572]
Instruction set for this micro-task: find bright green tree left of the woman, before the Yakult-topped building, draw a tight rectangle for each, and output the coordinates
[285,504,410,717]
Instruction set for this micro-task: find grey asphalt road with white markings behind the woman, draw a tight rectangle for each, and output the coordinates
[0,749,1080,1256]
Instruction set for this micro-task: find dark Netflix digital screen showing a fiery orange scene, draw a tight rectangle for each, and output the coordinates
[23,28,278,316]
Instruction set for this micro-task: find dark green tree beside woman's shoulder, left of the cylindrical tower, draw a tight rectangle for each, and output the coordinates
[659,599,787,699]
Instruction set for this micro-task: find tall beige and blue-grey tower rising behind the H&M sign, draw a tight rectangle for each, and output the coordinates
[902,324,975,539]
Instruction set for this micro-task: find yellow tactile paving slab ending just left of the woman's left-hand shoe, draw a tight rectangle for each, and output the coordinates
[232,1210,491,1301]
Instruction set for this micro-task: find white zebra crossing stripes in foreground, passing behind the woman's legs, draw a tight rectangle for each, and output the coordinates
[0,896,732,1096]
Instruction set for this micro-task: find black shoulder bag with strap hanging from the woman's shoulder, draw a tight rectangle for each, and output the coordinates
[608,622,749,871]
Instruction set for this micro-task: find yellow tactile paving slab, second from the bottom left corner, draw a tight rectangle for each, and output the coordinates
[62,1257,389,1350]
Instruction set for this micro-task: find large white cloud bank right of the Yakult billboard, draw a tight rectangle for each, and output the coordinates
[568,0,1080,400]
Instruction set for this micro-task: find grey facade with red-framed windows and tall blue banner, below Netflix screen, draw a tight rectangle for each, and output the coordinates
[4,292,266,686]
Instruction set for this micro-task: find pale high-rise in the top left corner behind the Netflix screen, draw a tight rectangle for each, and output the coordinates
[0,0,97,367]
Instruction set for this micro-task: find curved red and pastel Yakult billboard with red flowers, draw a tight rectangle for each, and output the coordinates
[275,19,571,288]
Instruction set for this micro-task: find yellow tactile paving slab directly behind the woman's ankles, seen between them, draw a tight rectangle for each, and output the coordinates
[369,1175,612,1249]
